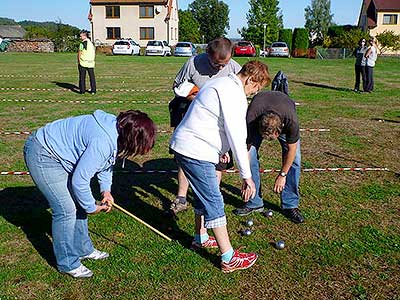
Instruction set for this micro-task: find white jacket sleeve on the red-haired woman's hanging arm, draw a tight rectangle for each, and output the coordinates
[219,87,251,179]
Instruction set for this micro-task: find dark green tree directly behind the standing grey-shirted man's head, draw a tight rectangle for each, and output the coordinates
[189,0,229,42]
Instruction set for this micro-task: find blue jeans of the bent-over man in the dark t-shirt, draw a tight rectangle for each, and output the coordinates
[246,134,301,209]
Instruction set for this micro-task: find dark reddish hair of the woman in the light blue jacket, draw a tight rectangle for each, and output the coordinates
[117,110,156,158]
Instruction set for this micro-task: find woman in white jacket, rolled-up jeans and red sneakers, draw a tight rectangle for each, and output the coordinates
[170,61,270,273]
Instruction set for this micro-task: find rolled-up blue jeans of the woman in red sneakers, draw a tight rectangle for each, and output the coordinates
[174,152,226,228]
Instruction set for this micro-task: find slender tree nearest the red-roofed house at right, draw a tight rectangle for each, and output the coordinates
[304,0,333,46]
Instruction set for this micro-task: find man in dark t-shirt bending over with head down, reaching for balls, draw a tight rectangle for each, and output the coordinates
[233,91,304,223]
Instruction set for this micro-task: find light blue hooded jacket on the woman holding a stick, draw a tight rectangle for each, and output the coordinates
[36,110,118,213]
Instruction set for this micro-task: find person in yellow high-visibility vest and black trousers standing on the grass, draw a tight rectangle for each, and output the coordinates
[78,30,96,95]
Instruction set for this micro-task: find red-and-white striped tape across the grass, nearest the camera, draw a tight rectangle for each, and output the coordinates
[0,167,389,176]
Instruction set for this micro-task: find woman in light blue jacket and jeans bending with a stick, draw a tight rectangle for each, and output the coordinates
[24,110,156,278]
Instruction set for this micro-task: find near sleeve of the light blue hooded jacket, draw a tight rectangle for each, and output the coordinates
[72,140,109,213]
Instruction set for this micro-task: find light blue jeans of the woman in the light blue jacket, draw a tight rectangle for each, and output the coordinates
[24,133,94,272]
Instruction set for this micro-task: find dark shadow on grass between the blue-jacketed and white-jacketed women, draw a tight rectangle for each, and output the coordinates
[112,158,220,268]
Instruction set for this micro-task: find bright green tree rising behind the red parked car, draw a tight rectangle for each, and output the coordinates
[239,0,283,49]
